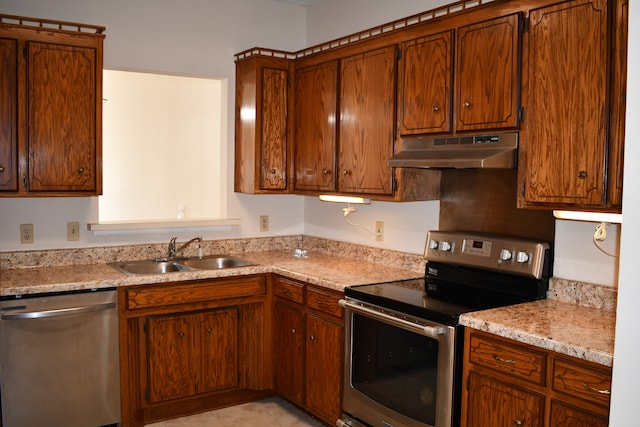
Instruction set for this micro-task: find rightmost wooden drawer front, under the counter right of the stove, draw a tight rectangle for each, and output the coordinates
[553,358,611,405]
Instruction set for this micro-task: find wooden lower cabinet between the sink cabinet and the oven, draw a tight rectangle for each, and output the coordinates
[273,276,344,425]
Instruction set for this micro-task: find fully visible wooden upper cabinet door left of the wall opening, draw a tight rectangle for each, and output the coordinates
[27,42,97,191]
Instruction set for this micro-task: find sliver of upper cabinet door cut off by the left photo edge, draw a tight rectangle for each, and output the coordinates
[0,38,18,191]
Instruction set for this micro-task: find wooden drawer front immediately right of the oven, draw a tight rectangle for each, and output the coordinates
[469,333,547,385]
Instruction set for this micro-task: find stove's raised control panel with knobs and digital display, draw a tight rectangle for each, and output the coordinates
[424,231,549,279]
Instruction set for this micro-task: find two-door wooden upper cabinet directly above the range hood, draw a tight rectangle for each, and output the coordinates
[398,14,521,136]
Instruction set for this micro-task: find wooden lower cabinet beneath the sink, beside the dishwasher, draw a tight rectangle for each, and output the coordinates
[118,275,274,427]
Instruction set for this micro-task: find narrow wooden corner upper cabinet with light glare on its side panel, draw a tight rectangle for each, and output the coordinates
[234,56,290,193]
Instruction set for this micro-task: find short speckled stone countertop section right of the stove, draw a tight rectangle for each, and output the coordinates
[460,299,616,366]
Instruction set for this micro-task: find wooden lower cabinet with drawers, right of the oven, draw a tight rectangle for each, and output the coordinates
[461,329,611,427]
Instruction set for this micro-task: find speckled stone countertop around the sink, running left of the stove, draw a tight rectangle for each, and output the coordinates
[0,251,422,296]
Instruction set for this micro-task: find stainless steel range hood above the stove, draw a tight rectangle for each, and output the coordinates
[389,132,518,169]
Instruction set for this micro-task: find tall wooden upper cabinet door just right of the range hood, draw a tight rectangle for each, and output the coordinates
[520,0,608,206]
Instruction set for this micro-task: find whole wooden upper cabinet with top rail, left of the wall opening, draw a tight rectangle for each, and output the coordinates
[0,15,104,197]
